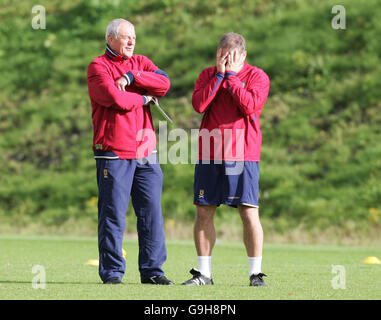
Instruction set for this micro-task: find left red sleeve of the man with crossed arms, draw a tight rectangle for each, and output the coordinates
[87,62,145,111]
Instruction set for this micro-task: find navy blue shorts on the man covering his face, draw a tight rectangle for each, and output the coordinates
[193,160,259,207]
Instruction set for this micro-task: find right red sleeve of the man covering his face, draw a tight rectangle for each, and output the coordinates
[226,69,270,115]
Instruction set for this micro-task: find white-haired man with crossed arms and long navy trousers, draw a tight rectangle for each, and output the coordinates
[87,19,173,285]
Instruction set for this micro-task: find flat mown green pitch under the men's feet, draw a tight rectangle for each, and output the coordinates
[0,235,381,300]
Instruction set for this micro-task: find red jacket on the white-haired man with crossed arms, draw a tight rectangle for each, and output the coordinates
[87,48,170,159]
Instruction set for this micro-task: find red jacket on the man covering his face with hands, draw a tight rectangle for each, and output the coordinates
[192,62,270,161]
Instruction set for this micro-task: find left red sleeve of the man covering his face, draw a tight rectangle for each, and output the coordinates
[192,70,224,113]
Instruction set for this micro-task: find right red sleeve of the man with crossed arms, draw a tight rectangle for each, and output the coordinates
[123,56,171,97]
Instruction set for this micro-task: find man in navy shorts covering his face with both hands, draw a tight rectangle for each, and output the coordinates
[183,33,270,287]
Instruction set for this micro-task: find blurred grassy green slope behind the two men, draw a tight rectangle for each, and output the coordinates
[0,0,381,240]
